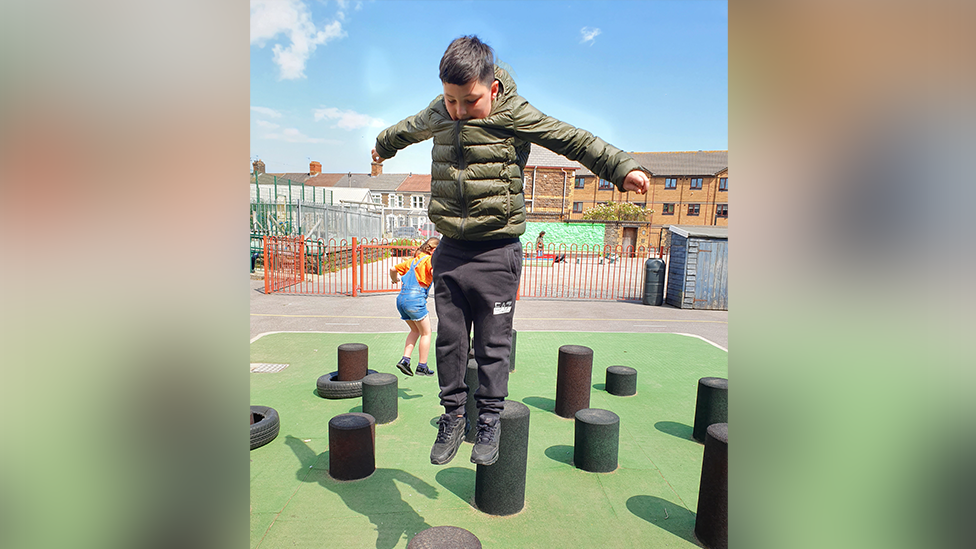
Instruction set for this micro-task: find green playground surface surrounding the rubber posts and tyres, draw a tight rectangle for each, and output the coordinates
[250,331,728,549]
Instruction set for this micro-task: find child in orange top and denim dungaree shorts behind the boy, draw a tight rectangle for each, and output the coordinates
[390,238,440,376]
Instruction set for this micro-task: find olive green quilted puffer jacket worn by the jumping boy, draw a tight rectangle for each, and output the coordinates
[376,66,646,240]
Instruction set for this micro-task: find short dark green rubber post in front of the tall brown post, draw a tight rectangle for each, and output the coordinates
[573,408,620,473]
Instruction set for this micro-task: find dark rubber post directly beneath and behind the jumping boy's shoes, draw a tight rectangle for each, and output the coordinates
[472,400,529,515]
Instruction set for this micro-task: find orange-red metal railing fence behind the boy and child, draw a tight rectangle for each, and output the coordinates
[264,236,654,301]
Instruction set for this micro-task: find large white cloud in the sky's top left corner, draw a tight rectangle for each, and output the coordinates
[251,0,346,80]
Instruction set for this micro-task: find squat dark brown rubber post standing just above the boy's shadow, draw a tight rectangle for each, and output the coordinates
[329,413,376,480]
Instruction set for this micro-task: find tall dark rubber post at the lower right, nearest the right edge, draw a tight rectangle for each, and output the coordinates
[695,423,729,549]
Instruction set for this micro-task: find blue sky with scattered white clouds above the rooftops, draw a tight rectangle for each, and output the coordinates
[249,0,728,173]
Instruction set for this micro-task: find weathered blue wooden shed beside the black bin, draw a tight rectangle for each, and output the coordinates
[664,225,729,311]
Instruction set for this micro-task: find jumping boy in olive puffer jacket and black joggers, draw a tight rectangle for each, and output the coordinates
[372,36,649,465]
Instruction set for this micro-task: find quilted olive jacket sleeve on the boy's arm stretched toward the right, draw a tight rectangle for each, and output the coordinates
[513,100,650,192]
